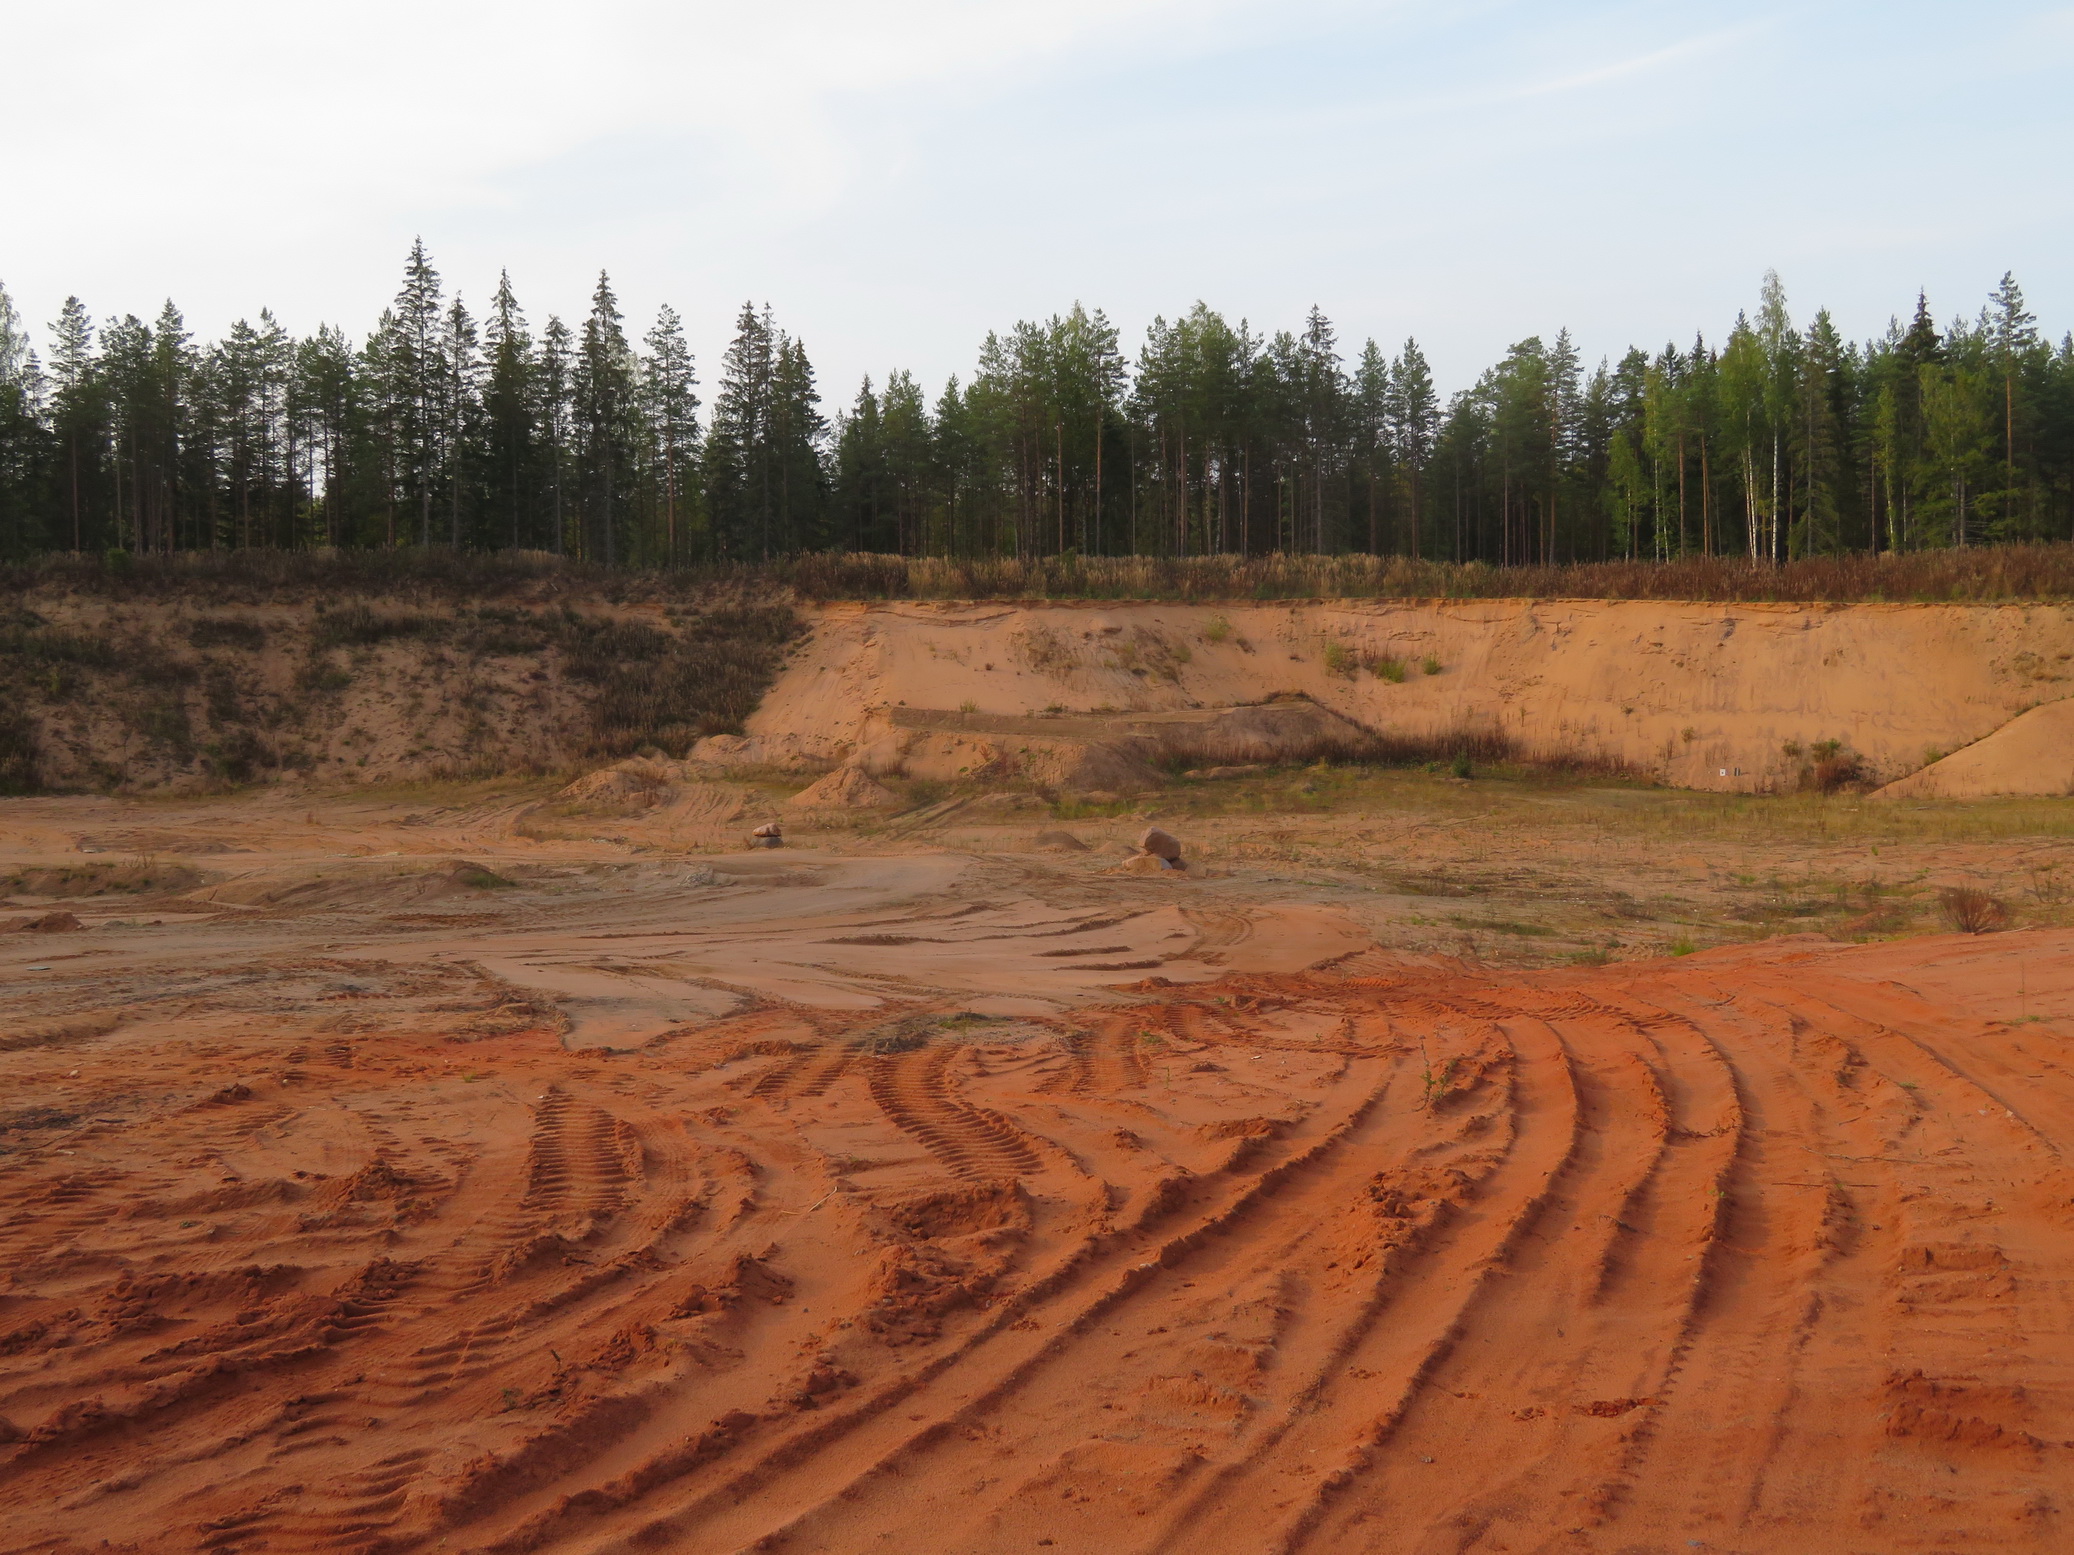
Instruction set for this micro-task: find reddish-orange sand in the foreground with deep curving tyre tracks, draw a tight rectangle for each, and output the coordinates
[0,887,2074,1555]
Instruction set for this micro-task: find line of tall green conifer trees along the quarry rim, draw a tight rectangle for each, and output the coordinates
[0,243,2074,566]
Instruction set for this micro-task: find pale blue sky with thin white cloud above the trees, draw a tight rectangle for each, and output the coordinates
[0,0,2074,408]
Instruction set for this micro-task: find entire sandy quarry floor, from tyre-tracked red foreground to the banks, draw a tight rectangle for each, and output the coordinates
[0,771,2074,1555]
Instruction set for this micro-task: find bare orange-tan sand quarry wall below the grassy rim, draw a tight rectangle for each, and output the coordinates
[701,599,2074,792]
